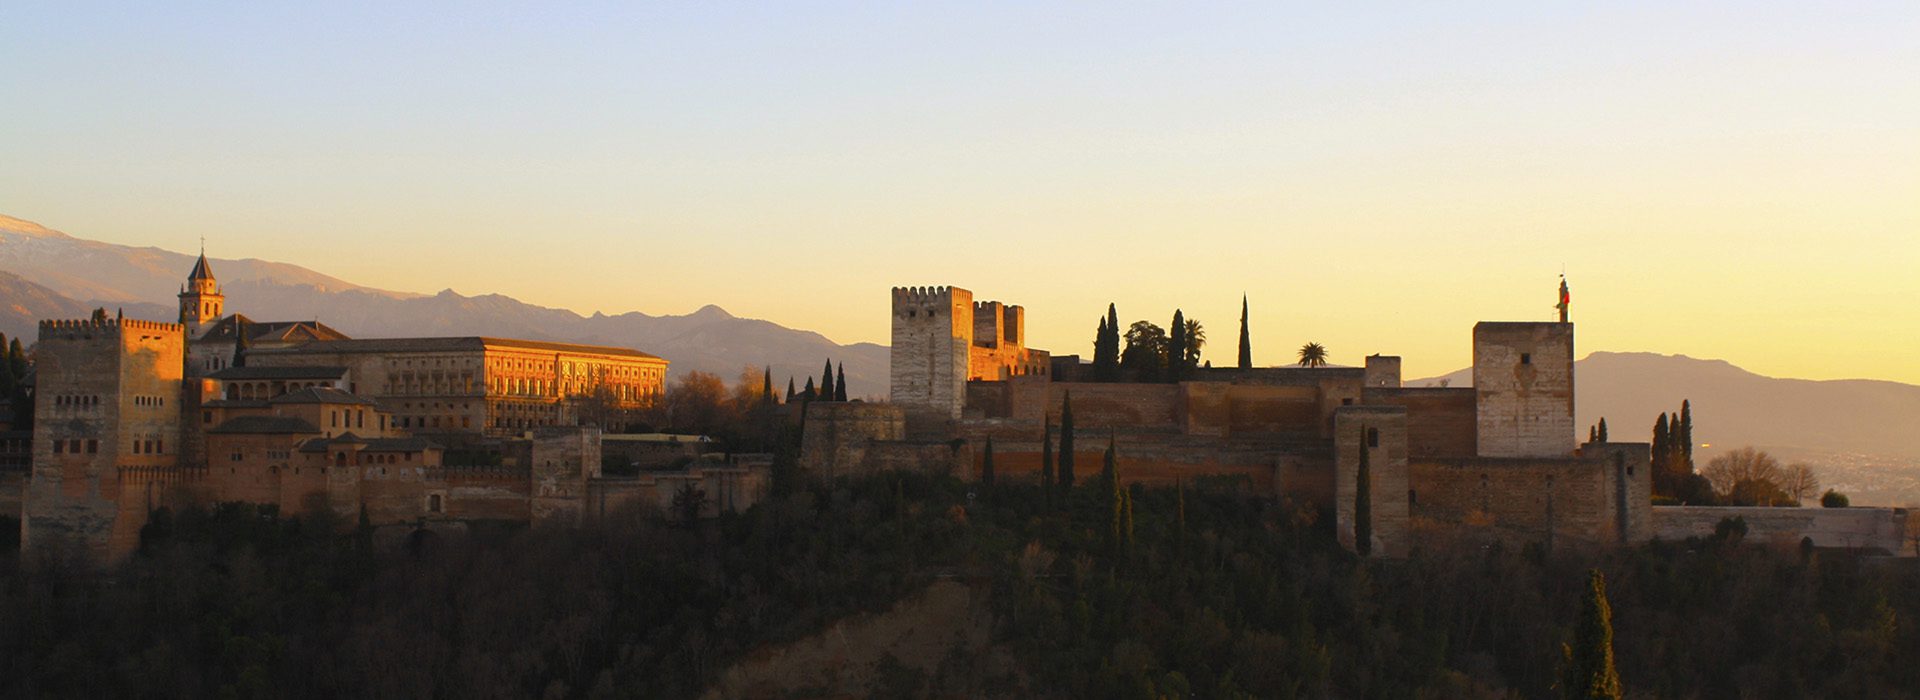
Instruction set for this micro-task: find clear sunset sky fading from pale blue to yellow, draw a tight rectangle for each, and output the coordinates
[0,0,1920,384]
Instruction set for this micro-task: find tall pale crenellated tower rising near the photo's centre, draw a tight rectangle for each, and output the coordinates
[889,288,973,420]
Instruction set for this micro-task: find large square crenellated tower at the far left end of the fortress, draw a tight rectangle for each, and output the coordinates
[21,318,186,558]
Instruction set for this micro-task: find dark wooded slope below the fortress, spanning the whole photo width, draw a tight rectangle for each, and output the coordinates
[0,466,1920,698]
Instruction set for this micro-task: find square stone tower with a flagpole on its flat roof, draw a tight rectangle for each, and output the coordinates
[1473,320,1574,456]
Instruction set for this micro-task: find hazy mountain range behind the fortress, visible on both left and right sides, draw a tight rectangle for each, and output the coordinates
[0,217,1920,502]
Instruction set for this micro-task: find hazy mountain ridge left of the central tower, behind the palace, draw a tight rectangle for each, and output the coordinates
[0,217,887,397]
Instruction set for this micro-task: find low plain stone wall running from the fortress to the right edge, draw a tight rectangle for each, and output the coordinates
[1651,506,1920,556]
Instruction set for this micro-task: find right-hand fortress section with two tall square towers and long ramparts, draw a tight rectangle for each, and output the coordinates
[803,281,1653,554]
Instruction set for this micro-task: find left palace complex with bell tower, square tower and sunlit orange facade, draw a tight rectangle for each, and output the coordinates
[19,255,768,560]
